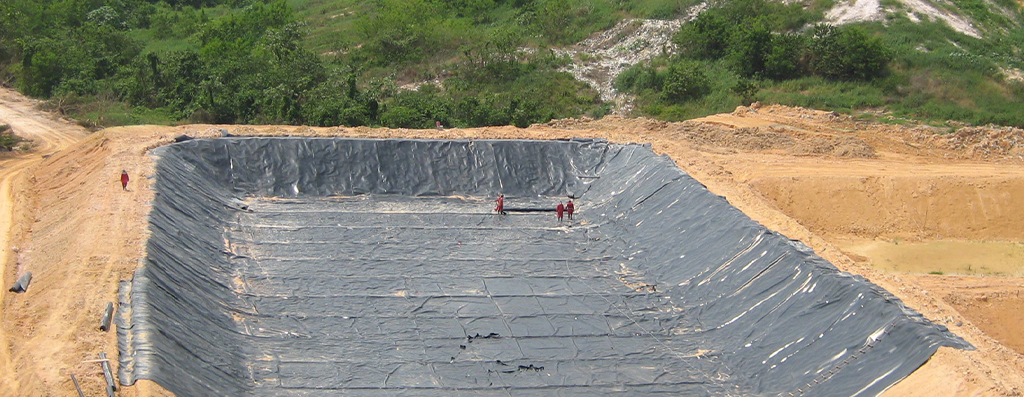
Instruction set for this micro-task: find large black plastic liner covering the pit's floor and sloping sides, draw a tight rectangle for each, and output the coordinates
[118,138,970,396]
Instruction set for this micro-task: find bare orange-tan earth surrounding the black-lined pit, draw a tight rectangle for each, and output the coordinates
[0,91,1024,396]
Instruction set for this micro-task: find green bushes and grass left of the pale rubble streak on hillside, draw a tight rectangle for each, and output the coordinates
[0,0,614,128]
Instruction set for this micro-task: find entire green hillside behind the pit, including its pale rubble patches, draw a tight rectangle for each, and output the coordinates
[0,0,1024,128]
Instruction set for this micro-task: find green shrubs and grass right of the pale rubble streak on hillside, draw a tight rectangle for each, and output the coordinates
[615,0,1024,126]
